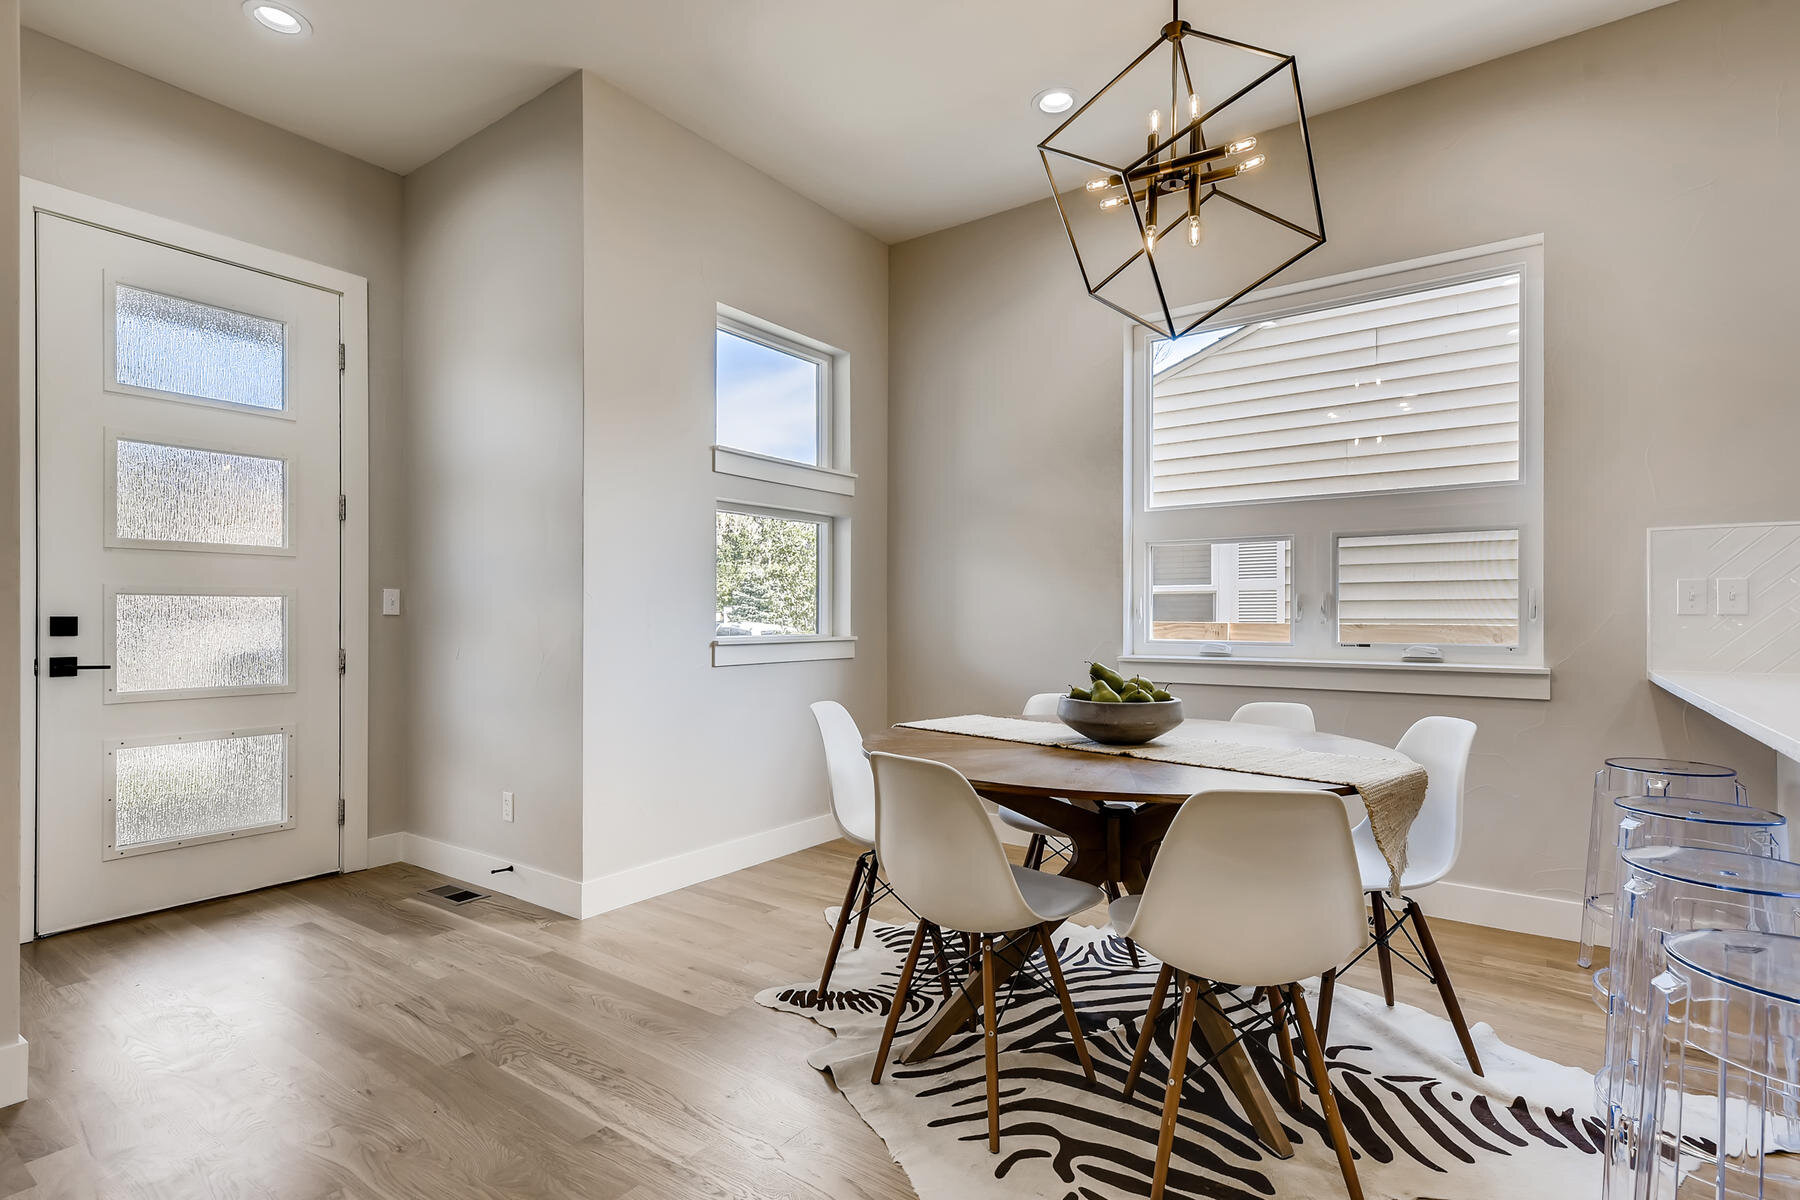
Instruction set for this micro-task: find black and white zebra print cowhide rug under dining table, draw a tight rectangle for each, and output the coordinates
[756,910,1604,1200]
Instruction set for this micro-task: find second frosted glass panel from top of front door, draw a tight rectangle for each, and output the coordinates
[113,437,288,549]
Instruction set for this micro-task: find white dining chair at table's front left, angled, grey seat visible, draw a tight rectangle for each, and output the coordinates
[869,752,1102,1153]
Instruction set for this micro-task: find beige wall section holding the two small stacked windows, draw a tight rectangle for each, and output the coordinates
[583,76,887,880]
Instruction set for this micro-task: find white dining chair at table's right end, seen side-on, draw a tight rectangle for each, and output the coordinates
[1346,716,1481,1074]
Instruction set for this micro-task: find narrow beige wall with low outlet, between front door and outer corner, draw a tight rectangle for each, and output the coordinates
[401,76,583,878]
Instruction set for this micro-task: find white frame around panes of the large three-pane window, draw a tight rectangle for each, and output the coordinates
[1121,237,1550,700]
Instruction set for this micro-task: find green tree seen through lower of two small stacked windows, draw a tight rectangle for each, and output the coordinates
[716,513,819,633]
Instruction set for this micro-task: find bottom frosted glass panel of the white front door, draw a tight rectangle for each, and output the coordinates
[106,730,288,856]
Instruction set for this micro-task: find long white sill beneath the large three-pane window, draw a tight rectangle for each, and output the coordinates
[1120,655,1550,700]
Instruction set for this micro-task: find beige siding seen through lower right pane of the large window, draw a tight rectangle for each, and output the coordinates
[1337,529,1519,646]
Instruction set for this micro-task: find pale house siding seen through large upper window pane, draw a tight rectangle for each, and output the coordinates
[1150,273,1519,507]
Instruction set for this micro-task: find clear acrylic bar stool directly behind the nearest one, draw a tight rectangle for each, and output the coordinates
[1595,846,1800,1128]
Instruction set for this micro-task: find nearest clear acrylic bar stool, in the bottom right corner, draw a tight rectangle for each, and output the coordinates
[1604,930,1800,1200]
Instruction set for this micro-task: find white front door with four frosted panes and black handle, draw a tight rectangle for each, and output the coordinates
[36,212,340,934]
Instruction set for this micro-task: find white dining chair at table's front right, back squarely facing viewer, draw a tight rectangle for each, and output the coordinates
[1109,790,1366,1200]
